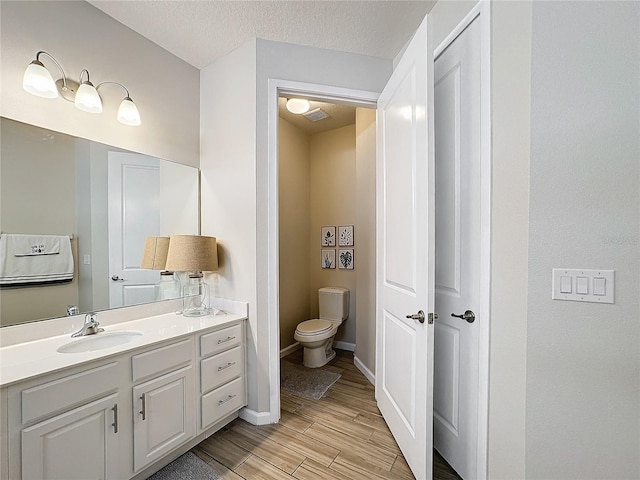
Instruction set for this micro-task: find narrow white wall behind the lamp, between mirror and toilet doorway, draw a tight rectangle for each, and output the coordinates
[200,41,258,411]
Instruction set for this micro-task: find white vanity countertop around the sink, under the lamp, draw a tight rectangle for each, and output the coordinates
[0,313,246,387]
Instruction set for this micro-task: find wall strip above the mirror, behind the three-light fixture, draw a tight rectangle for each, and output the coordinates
[0,1,200,167]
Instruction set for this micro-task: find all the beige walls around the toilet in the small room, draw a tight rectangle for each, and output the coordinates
[279,116,375,352]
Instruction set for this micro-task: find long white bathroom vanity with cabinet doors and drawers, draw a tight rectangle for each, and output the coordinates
[0,315,246,480]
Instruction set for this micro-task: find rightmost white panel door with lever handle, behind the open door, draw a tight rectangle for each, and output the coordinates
[433,18,482,478]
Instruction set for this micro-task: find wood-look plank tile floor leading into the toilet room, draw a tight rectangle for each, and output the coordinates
[192,350,460,480]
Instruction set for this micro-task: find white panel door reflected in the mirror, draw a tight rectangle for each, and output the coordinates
[108,156,160,308]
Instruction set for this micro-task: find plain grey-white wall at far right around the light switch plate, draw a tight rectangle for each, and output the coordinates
[526,2,640,479]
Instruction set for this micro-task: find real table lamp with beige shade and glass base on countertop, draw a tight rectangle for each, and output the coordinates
[165,235,218,317]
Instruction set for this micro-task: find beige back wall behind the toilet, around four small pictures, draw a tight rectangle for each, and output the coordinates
[309,125,359,344]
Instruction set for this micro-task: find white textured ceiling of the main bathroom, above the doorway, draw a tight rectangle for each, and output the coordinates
[88,0,435,68]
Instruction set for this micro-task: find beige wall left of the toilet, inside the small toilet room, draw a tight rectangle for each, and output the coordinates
[278,119,317,349]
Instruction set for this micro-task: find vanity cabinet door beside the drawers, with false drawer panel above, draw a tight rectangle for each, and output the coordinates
[131,337,196,472]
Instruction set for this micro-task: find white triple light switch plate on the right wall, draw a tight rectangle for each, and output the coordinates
[551,268,614,303]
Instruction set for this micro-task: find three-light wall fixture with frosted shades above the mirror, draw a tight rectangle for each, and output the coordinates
[22,50,140,127]
